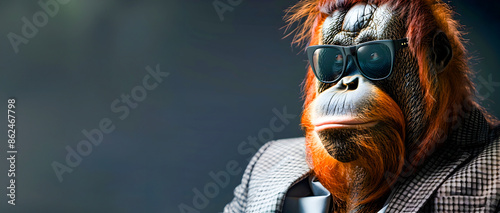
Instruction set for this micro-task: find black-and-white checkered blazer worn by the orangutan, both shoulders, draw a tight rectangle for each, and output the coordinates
[224,110,500,213]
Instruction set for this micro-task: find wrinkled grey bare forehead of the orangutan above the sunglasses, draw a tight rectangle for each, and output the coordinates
[321,3,405,45]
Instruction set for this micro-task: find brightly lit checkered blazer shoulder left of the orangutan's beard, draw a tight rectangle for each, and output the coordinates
[224,138,310,213]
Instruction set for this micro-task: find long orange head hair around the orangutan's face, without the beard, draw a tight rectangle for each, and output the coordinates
[285,0,488,174]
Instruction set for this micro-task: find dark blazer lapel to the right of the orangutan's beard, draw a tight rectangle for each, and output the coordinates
[386,108,489,213]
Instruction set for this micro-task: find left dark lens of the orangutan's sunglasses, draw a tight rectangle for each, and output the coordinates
[313,48,344,82]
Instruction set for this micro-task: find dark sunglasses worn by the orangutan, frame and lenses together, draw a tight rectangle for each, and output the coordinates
[306,38,408,83]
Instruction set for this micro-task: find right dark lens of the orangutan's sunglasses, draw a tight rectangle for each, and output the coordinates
[357,44,392,80]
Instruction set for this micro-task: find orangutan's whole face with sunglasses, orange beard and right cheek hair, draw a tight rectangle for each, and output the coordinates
[292,0,458,212]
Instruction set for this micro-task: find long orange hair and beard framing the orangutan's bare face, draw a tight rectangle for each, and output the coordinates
[285,0,496,209]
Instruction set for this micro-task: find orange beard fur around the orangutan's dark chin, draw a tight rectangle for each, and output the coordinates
[303,90,405,212]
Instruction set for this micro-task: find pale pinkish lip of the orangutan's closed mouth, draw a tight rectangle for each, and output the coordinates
[312,116,378,131]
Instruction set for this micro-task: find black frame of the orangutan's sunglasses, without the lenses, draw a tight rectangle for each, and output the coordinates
[306,38,408,83]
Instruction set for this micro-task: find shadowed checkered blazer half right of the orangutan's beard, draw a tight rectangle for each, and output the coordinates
[387,109,500,212]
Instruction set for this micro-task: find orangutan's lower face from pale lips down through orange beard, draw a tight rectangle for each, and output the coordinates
[303,89,405,208]
